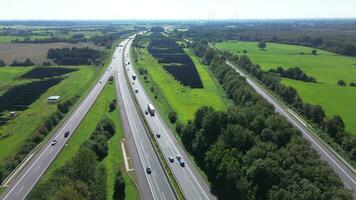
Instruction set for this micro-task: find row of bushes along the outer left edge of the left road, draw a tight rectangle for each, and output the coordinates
[0,96,79,184]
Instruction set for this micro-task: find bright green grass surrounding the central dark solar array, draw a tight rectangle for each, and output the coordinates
[135,48,226,123]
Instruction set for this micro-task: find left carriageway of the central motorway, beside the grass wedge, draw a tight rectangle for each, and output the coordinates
[115,40,176,199]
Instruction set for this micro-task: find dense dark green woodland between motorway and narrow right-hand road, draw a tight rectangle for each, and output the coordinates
[176,46,352,200]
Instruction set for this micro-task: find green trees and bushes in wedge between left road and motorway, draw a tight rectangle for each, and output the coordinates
[29,117,125,200]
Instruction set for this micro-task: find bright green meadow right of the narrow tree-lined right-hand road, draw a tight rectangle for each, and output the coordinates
[215,42,356,134]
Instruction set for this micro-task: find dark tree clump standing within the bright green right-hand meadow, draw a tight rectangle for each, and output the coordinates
[269,67,317,83]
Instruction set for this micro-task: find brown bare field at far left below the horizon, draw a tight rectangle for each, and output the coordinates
[0,43,103,65]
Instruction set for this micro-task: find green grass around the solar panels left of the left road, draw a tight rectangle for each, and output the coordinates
[0,67,98,163]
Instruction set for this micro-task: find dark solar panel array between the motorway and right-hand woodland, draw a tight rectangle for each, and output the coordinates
[148,36,204,88]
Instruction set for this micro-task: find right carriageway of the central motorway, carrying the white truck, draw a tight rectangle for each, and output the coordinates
[124,35,216,200]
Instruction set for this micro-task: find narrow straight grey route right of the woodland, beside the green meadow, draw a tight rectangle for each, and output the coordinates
[226,61,356,197]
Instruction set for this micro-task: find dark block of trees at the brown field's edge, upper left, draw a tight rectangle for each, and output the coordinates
[47,47,103,66]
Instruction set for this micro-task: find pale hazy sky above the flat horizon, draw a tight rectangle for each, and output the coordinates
[0,0,356,20]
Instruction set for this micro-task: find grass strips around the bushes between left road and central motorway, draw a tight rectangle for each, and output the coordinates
[41,84,139,199]
